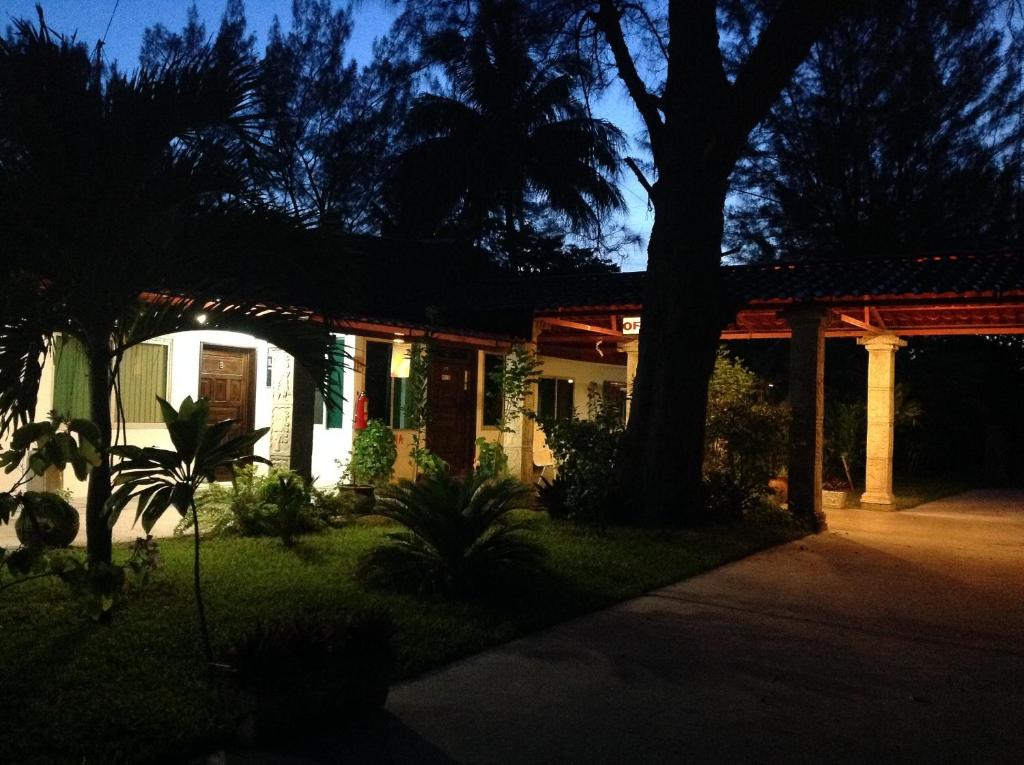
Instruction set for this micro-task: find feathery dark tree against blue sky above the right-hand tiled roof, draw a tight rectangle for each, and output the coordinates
[729,0,1024,259]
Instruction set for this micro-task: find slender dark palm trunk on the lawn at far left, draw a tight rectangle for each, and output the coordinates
[85,337,114,564]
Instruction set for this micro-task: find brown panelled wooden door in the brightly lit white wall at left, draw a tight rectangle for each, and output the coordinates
[199,345,256,479]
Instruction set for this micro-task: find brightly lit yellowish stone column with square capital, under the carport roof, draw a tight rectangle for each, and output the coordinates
[857,335,906,505]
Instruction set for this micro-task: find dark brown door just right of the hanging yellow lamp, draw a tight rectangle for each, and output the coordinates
[427,348,476,475]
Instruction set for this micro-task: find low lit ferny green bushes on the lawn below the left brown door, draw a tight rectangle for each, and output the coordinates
[174,465,327,545]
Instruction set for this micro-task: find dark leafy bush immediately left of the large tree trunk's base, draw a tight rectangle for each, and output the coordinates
[539,385,624,523]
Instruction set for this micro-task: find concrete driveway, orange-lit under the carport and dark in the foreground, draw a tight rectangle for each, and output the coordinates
[382,492,1024,763]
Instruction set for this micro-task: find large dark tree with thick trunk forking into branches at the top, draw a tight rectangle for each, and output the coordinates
[395,0,847,522]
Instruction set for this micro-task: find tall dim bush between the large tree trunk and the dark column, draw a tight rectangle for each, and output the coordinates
[703,348,788,519]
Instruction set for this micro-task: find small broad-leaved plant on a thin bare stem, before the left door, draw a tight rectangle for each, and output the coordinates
[106,396,269,662]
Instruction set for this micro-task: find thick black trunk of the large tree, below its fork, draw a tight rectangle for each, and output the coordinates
[617,172,730,524]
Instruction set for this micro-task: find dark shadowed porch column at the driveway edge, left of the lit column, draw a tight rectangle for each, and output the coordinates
[785,307,826,532]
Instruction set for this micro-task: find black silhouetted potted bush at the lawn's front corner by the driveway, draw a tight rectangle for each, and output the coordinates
[227,608,395,741]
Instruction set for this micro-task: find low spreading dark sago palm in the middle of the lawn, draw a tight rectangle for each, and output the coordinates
[359,474,544,594]
